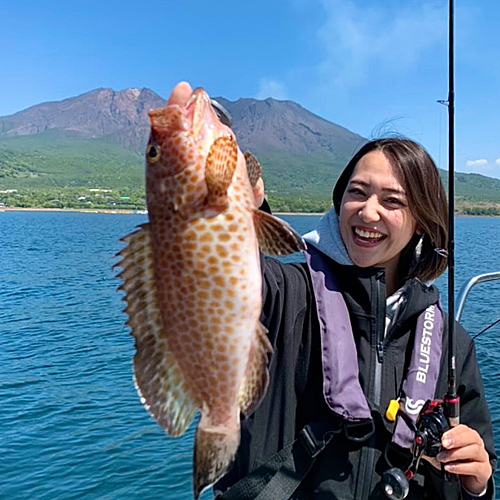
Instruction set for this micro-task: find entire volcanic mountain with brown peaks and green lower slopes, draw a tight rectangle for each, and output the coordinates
[0,87,500,210]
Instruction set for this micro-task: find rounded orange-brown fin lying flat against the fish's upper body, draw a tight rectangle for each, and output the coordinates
[205,136,238,205]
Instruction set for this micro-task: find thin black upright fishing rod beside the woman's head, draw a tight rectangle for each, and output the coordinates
[443,0,460,427]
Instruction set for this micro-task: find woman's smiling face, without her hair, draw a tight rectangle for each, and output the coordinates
[339,151,417,280]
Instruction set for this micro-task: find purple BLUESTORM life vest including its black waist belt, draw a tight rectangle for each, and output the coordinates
[214,250,443,500]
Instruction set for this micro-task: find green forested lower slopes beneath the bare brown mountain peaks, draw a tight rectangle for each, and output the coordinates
[0,137,500,215]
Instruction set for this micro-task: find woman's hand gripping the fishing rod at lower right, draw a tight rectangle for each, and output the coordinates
[433,424,492,495]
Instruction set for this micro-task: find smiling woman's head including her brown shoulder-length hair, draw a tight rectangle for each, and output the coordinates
[333,139,448,293]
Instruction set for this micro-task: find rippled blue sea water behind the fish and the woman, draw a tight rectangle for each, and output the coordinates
[0,212,500,500]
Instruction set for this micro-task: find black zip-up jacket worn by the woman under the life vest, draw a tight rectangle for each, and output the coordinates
[215,259,496,500]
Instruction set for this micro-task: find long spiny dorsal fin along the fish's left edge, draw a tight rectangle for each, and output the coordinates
[116,224,198,436]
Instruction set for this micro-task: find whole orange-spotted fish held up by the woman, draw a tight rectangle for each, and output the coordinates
[115,82,305,499]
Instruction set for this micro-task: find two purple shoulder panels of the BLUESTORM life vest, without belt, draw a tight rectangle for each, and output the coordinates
[304,246,443,449]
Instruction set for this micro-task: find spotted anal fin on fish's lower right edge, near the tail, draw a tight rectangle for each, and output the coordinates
[239,323,273,417]
